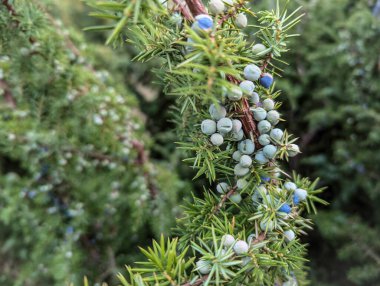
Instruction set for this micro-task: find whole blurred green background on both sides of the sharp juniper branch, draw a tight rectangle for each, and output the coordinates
[0,0,380,285]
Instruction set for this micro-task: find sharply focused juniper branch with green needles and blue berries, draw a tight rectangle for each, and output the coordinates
[88,0,325,286]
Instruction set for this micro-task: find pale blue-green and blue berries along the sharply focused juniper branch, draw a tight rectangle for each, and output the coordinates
[193,4,307,282]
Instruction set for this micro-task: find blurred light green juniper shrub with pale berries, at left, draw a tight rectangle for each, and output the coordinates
[0,0,186,285]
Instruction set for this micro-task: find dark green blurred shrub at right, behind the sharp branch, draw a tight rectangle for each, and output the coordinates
[281,0,380,285]
